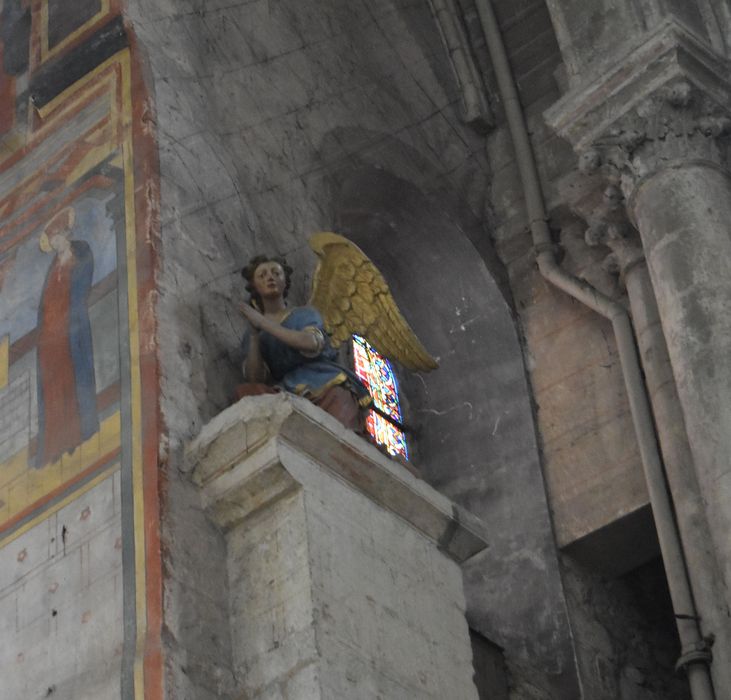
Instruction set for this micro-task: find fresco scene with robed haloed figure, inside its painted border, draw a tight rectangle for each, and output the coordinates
[0,54,124,532]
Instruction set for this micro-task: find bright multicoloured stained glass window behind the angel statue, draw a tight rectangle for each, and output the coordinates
[353,335,409,459]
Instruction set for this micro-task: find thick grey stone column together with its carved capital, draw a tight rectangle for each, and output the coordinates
[546,21,731,697]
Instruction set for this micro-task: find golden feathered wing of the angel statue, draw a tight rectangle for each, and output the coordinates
[310,233,438,370]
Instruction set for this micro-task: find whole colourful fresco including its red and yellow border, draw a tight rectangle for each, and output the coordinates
[0,0,162,698]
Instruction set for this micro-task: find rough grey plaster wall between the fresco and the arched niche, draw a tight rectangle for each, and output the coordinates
[120,0,506,697]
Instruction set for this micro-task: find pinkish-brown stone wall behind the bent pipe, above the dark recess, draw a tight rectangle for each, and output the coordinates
[468,0,648,547]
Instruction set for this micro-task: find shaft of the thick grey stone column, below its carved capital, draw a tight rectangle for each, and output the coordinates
[630,153,731,585]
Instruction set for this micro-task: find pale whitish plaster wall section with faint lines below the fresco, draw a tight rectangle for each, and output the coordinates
[0,472,123,700]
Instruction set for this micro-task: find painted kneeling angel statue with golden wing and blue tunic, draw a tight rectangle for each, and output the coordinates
[236,233,437,432]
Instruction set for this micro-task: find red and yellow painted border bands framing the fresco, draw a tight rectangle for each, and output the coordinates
[0,21,163,700]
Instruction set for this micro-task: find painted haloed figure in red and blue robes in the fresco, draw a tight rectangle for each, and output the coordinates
[36,207,99,467]
